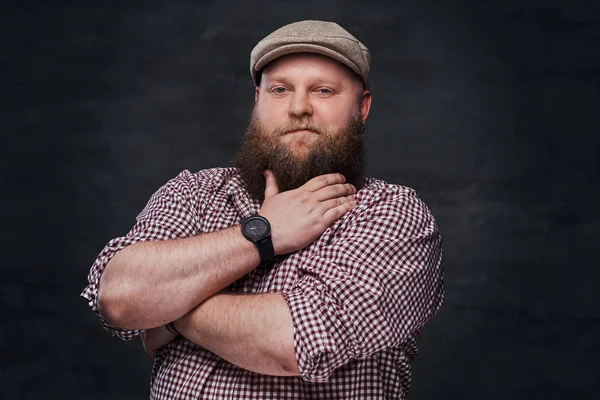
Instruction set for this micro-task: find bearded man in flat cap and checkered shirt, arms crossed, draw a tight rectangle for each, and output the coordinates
[82,21,443,399]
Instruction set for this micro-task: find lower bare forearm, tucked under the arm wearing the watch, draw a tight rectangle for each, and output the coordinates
[175,293,298,376]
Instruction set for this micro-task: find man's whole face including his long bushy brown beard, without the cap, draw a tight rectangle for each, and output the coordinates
[235,53,371,199]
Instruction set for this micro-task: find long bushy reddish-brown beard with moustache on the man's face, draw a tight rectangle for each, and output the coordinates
[235,111,366,202]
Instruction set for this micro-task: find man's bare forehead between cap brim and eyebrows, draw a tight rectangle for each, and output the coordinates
[261,53,362,85]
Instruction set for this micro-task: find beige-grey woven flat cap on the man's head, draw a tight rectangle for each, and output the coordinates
[250,20,371,89]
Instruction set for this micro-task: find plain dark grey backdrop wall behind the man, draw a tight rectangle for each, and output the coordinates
[0,0,600,399]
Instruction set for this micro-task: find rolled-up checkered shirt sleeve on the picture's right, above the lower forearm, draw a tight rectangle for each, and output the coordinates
[283,190,444,382]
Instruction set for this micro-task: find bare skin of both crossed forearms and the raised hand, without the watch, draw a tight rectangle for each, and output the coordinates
[98,174,356,376]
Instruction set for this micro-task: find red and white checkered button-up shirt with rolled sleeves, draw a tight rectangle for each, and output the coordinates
[81,168,444,400]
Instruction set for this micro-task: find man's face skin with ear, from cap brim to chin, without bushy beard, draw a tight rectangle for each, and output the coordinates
[254,53,371,158]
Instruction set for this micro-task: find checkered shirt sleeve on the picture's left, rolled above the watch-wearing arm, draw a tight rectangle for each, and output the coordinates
[81,170,202,340]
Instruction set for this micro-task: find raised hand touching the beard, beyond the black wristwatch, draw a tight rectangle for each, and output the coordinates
[259,170,356,254]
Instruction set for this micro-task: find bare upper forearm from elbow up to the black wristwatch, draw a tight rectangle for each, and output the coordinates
[98,226,260,329]
